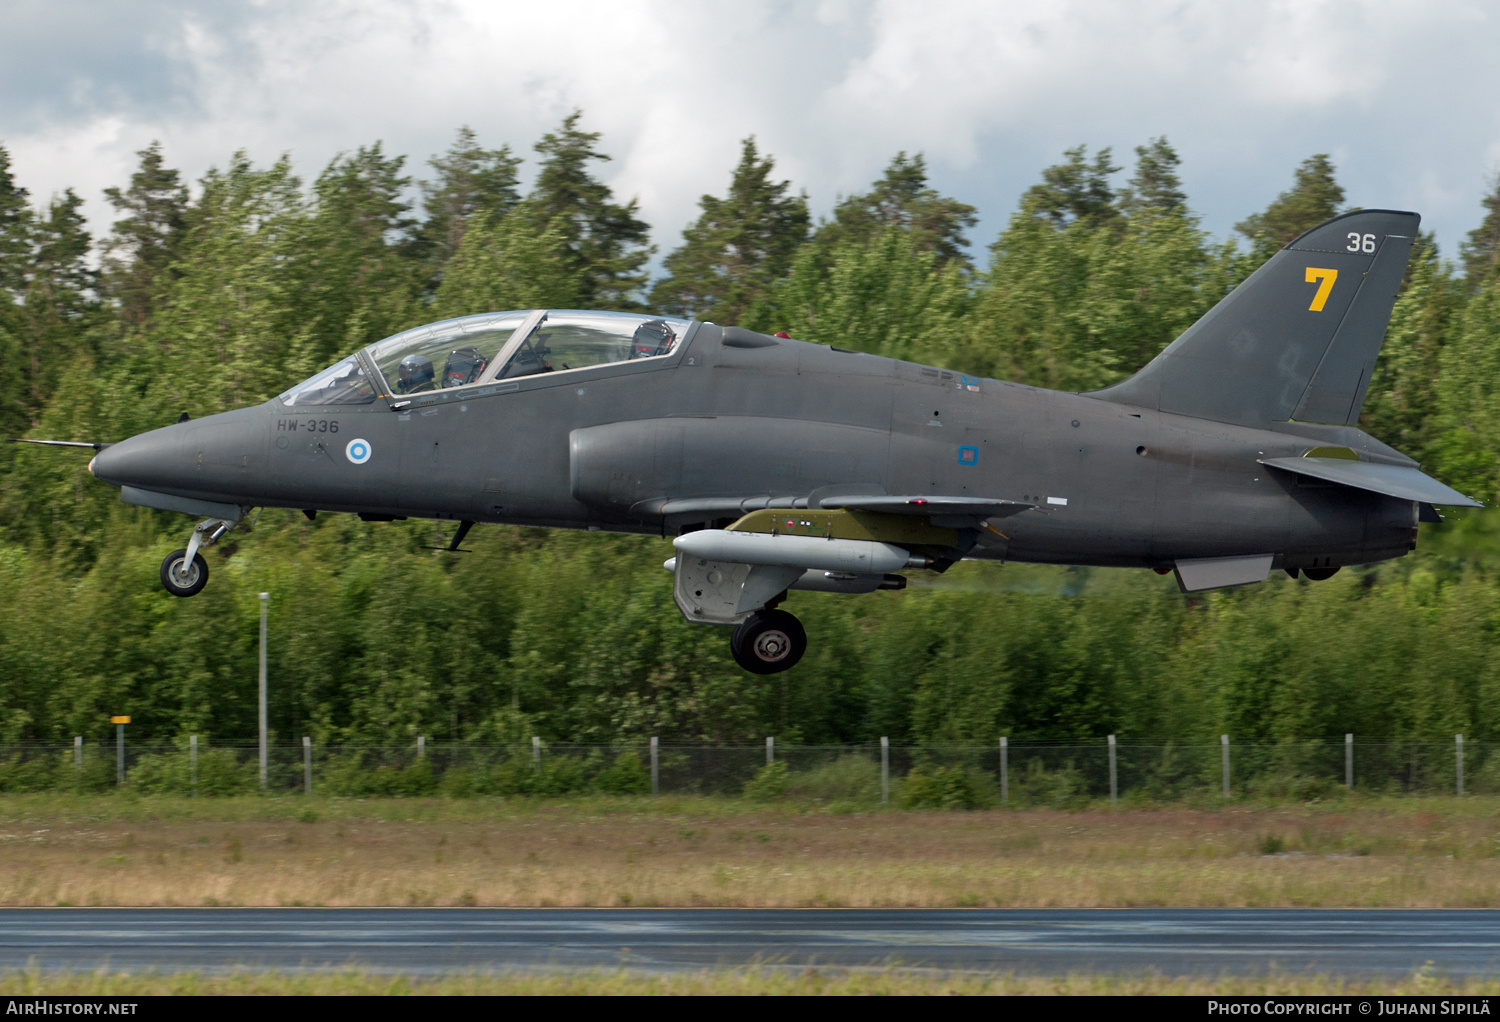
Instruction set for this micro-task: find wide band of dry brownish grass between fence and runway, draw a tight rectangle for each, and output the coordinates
[0,795,1500,906]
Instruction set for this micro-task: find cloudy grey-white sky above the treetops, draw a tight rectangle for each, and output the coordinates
[0,0,1500,271]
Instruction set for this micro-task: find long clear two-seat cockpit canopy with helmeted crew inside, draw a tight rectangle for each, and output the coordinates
[282,309,689,407]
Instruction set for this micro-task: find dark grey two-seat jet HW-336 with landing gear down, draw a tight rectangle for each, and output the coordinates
[17,210,1479,674]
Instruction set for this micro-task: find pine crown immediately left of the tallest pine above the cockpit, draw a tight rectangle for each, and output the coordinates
[422,125,521,273]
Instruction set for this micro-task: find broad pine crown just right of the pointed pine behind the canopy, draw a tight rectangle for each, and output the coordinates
[818,152,978,266]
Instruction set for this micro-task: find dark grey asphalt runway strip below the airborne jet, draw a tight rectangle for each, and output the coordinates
[0,908,1500,975]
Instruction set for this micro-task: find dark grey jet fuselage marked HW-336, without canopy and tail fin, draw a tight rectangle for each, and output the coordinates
[95,324,1418,567]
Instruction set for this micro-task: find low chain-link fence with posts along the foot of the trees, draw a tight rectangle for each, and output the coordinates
[0,737,1482,807]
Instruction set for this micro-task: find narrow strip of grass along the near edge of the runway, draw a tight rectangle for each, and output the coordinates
[0,968,1500,998]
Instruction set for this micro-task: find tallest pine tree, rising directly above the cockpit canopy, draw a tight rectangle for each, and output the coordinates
[530,110,654,309]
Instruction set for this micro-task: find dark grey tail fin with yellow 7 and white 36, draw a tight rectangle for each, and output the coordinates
[1091,210,1422,426]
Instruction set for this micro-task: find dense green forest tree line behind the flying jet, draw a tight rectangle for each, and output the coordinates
[0,113,1500,744]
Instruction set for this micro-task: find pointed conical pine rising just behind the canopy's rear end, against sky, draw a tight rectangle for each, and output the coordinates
[651,137,809,323]
